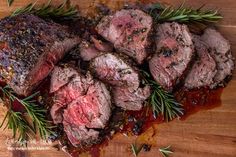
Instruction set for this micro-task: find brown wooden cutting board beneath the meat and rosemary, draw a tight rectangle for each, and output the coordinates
[0,0,236,157]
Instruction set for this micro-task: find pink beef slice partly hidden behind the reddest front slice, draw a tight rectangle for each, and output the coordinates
[50,67,93,124]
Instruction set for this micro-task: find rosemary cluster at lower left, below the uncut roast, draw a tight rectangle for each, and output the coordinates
[0,86,54,141]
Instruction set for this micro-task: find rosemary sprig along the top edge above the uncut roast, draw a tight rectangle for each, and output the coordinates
[11,0,78,20]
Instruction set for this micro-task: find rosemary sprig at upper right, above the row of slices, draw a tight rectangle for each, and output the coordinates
[149,3,223,23]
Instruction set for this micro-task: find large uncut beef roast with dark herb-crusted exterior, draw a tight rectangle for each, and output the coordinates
[0,14,80,96]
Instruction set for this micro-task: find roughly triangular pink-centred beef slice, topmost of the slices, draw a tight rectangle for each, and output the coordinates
[96,9,152,64]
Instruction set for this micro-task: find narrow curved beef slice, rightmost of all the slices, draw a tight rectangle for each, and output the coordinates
[201,28,234,88]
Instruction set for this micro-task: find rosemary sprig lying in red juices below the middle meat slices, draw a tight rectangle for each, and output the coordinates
[141,70,184,121]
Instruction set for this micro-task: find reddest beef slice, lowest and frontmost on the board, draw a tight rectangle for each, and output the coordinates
[63,78,111,146]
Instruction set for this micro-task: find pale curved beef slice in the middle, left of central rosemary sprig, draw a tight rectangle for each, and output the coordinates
[90,53,150,110]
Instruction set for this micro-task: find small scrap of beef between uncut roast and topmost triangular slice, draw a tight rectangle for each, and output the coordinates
[79,37,113,61]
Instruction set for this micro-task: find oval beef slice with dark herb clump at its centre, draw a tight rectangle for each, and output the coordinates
[149,22,194,91]
